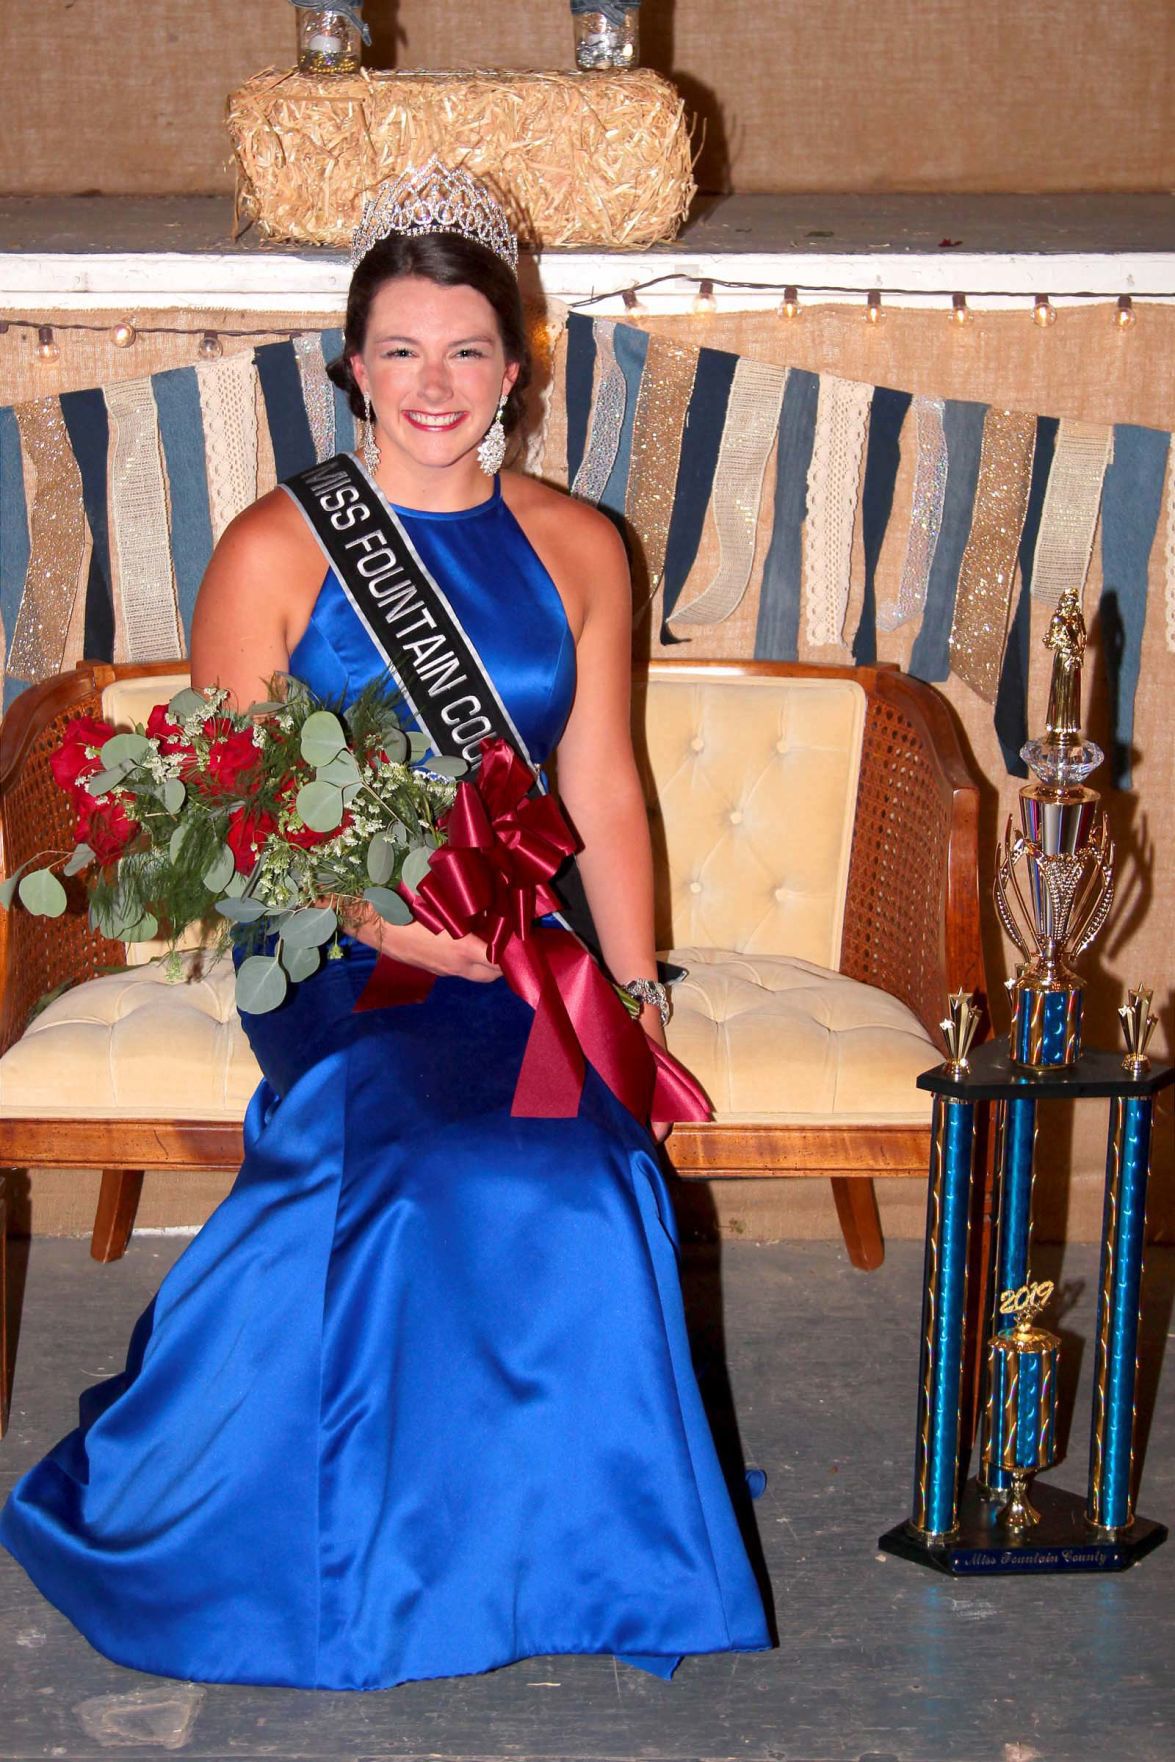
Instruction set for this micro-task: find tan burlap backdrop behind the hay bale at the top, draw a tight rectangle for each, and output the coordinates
[0,0,1175,194]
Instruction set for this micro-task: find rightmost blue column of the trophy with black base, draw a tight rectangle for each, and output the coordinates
[1087,1096,1152,1531]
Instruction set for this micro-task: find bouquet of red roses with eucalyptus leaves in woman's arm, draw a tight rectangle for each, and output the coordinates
[0,680,467,1013]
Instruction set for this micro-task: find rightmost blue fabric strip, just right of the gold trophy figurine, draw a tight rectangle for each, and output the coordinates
[1097,423,1171,789]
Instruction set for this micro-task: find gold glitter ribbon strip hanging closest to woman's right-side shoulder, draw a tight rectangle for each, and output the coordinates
[624,337,698,597]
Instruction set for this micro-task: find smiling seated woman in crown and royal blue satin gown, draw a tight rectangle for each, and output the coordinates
[0,164,768,1688]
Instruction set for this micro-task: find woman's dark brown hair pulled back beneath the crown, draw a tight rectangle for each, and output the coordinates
[326,233,530,433]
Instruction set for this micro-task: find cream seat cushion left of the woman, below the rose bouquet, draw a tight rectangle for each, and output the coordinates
[0,955,259,1121]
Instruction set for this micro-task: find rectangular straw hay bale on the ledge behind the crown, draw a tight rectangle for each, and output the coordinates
[227,67,694,250]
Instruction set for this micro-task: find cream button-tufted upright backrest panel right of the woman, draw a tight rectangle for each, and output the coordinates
[636,670,865,967]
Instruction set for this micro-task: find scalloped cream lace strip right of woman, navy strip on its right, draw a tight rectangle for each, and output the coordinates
[803,374,874,648]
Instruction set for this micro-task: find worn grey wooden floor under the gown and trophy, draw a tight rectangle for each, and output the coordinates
[0,1237,1175,1762]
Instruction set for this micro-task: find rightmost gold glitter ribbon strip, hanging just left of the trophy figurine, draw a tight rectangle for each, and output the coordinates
[951,409,1036,703]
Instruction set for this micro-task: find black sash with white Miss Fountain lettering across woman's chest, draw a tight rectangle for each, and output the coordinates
[282,453,599,957]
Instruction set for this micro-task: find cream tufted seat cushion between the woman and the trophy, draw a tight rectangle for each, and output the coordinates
[668,948,939,1126]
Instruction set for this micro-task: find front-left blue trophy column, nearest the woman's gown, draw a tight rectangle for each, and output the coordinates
[911,1096,976,1536]
